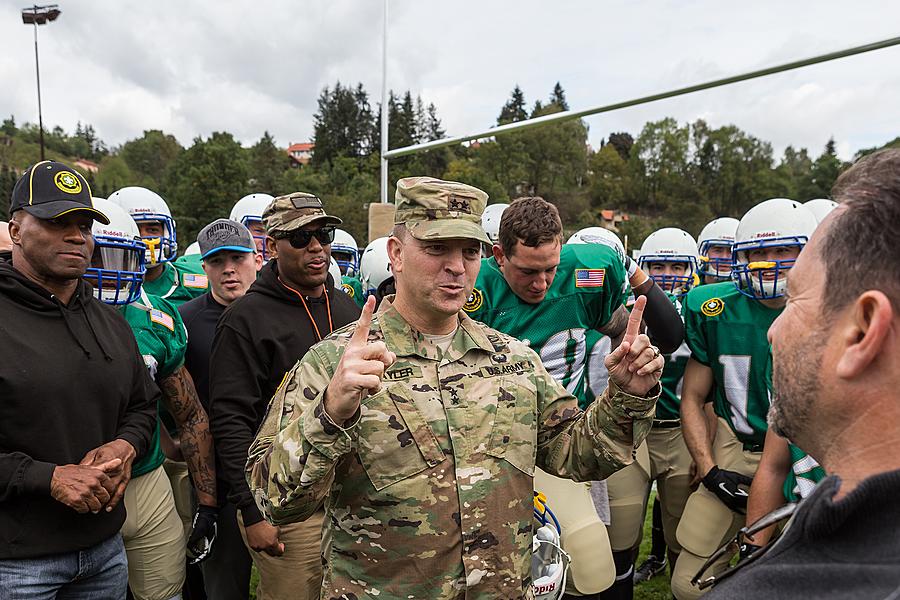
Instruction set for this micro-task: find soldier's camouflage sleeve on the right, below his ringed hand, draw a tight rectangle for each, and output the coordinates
[535,352,661,481]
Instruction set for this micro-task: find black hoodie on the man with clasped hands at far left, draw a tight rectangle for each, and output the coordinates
[0,261,159,559]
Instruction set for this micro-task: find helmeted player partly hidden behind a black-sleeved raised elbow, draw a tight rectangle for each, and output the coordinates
[607,227,699,592]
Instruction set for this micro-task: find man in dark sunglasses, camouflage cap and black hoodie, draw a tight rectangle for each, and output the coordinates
[209,192,360,600]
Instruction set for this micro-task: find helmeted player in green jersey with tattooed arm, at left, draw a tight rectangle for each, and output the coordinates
[84,198,217,600]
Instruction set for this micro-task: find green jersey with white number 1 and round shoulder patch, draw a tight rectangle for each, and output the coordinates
[683,281,782,448]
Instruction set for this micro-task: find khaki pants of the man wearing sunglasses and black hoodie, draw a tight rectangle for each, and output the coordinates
[238,509,325,600]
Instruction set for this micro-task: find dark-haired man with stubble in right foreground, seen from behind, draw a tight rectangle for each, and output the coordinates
[709,149,900,599]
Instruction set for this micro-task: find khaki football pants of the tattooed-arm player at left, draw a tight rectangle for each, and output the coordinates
[122,467,185,600]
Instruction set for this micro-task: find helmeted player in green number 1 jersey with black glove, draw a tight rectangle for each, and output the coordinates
[672,198,816,600]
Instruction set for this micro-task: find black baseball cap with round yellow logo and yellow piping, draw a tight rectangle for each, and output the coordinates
[9,160,109,225]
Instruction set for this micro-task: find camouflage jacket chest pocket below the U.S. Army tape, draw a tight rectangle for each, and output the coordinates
[487,376,537,475]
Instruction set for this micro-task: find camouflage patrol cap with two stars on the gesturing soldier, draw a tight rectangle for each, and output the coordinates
[394,177,491,245]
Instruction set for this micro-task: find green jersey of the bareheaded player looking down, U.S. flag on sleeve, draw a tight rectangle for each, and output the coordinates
[463,244,626,400]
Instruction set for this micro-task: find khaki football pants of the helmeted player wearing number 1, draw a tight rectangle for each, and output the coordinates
[672,417,762,600]
